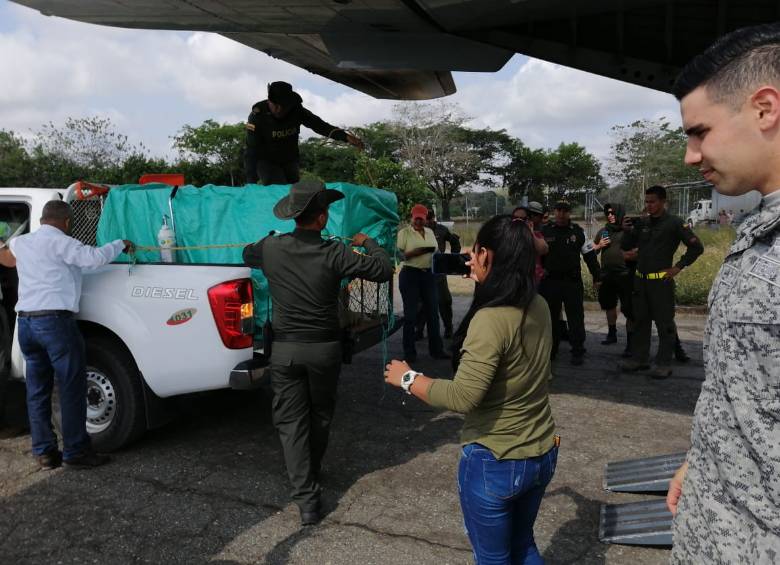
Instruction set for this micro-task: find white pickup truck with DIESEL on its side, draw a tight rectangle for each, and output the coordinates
[0,188,400,451]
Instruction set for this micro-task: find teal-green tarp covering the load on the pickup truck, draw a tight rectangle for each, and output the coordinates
[97,183,398,328]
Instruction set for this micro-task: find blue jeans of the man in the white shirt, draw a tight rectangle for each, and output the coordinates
[18,315,90,460]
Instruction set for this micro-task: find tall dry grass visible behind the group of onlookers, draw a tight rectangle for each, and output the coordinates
[448,222,735,306]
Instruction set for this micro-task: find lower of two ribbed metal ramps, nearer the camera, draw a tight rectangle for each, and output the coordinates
[599,498,672,546]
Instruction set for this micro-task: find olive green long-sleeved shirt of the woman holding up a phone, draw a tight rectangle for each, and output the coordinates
[428,295,555,459]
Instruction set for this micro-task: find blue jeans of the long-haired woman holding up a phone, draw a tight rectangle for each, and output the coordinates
[458,443,558,565]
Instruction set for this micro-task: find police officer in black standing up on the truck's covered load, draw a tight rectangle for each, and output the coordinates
[244,81,363,184]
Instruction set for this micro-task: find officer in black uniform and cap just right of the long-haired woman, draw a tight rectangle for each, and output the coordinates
[539,202,599,365]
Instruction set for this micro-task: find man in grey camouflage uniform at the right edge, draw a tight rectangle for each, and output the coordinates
[667,22,780,564]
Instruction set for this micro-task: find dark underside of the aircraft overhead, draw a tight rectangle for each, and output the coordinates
[13,0,780,100]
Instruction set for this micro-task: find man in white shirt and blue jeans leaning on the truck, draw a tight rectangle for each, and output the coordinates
[0,200,133,469]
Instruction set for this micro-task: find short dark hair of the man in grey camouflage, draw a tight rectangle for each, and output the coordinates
[672,22,780,108]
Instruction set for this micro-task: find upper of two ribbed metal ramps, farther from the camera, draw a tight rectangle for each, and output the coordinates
[604,451,686,492]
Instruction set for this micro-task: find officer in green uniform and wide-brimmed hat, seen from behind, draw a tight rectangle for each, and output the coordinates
[244,181,393,525]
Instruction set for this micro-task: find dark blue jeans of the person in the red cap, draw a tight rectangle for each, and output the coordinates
[398,267,444,355]
